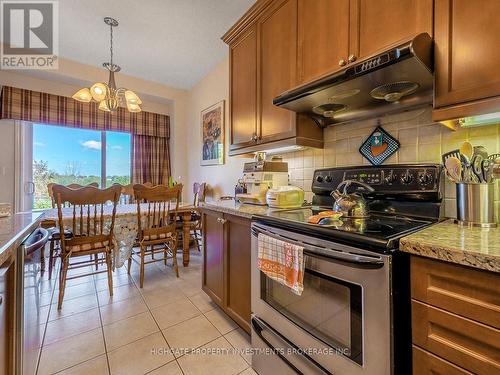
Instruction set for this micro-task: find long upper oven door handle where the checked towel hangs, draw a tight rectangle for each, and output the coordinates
[252,228,384,268]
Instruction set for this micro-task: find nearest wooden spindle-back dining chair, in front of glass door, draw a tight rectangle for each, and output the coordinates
[52,185,121,309]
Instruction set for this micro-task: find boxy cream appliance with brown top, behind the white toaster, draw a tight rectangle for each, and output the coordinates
[236,160,288,206]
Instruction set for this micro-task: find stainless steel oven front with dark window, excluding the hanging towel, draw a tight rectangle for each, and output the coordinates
[252,223,394,375]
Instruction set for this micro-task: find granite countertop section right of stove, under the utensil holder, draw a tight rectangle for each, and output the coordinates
[399,220,500,272]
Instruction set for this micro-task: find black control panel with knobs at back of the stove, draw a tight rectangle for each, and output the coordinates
[312,164,442,193]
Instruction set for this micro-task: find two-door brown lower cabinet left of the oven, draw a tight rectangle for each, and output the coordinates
[202,209,251,333]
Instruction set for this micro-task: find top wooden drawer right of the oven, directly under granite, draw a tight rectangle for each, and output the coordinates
[411,256,500,329]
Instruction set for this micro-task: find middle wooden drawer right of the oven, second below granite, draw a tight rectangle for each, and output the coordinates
[412,300,500,375]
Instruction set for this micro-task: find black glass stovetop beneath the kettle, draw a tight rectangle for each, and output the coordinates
[254,207,434,253]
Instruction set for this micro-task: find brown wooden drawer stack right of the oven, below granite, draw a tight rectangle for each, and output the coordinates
[411,256,500,375]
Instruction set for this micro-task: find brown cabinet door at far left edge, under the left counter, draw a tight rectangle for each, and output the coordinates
[0,259,16,375]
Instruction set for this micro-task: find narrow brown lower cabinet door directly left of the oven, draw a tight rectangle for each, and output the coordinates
[224,215,251,333]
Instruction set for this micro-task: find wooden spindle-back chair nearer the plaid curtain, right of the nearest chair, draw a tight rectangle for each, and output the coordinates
[128,185,182,288]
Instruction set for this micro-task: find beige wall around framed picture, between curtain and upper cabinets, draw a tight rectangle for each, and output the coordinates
[183,57,249,203]
